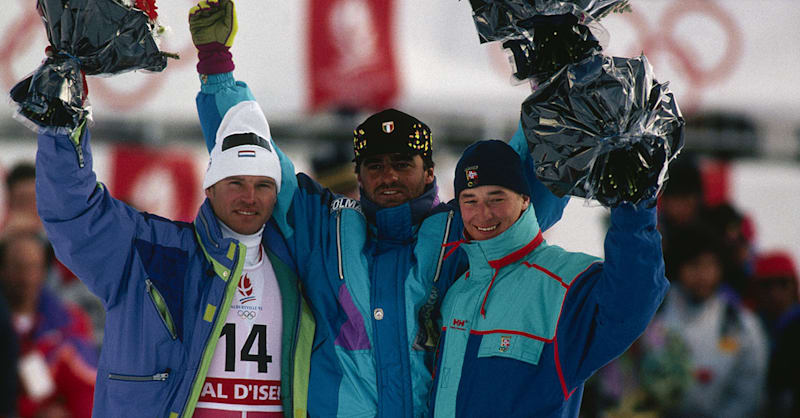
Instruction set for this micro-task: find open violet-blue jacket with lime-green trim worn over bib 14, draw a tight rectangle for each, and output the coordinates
[36,125,314,418]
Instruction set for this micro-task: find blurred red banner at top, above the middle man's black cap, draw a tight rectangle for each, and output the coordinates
[308,0,398,110]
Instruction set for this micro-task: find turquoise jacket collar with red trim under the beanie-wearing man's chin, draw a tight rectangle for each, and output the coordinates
[461,205,543,280]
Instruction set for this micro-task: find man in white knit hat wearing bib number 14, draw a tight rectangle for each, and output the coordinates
[36,91,314,418]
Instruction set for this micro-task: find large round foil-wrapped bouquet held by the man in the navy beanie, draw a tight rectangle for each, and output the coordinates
[522,54,684,207]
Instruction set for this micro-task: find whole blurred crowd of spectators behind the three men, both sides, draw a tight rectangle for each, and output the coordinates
[0,149,800,418]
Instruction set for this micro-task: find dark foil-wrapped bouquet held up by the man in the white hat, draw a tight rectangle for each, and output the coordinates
[11,0,176,130]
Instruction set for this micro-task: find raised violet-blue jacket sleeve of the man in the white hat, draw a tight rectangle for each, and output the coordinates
[36,125,188,307]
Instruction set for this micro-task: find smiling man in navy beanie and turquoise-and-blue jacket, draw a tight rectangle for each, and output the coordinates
[430,141,668,417]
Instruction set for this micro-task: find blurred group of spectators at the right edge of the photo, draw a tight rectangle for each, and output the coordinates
[582,154,800,418]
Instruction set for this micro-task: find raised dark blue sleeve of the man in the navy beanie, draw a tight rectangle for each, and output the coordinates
[556,203,669,396]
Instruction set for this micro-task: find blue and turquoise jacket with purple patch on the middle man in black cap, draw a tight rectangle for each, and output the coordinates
[197,73,568,418]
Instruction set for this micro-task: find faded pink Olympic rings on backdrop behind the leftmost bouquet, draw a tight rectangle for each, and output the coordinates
[0,0,196,110]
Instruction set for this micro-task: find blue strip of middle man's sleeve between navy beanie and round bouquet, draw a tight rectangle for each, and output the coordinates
[509,122,569,231]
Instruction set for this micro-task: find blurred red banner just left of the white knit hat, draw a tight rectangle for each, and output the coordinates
[111,146,202,222]
